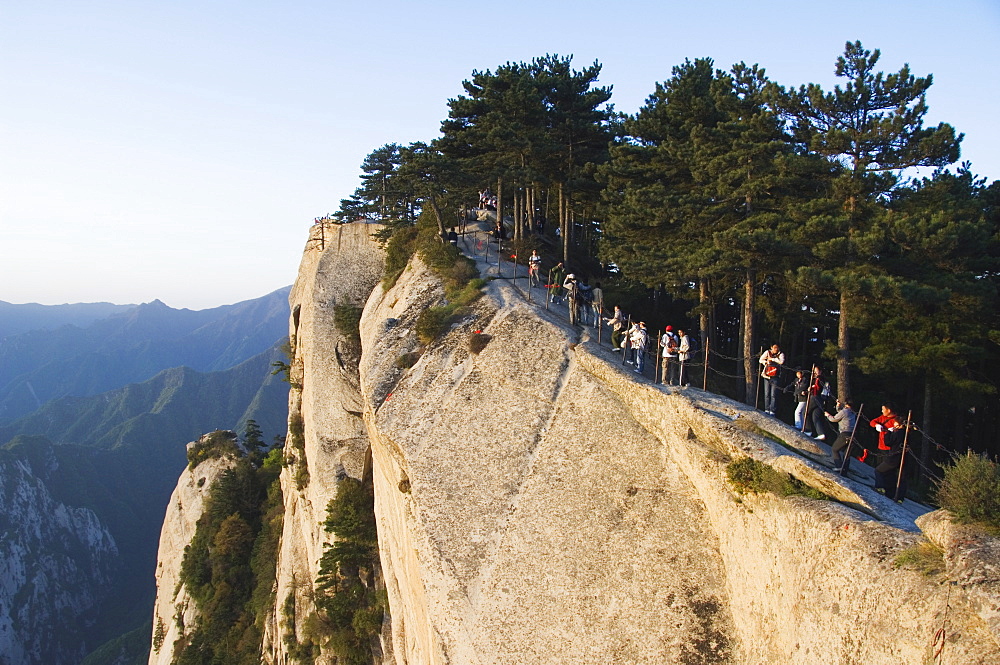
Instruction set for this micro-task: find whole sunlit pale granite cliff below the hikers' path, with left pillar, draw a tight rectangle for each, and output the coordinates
[150,225,1000,665]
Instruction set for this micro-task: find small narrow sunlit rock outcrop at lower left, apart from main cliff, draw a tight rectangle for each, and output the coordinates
[149,435,235,665]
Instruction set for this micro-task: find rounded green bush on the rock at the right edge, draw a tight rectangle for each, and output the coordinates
[935,451,1000,529]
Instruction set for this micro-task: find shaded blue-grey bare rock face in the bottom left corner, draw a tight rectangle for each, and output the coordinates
[0,438,118,665]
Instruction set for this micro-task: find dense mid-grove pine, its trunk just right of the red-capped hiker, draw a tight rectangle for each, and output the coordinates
[598,58,725,350]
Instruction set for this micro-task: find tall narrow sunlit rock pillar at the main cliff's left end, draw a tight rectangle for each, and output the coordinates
[264,224,384,663]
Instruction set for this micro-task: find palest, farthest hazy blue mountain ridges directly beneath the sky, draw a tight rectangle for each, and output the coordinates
[0,287,289,423]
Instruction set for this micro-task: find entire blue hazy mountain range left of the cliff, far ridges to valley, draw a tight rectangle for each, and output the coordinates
[0,289,288,665]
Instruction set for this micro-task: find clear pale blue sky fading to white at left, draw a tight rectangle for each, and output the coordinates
[0,0,1000,309]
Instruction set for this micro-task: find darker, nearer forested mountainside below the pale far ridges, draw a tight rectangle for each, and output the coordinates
[0,340,288,663]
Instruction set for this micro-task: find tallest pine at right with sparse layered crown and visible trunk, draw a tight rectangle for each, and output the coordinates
[773,42,962,400]
